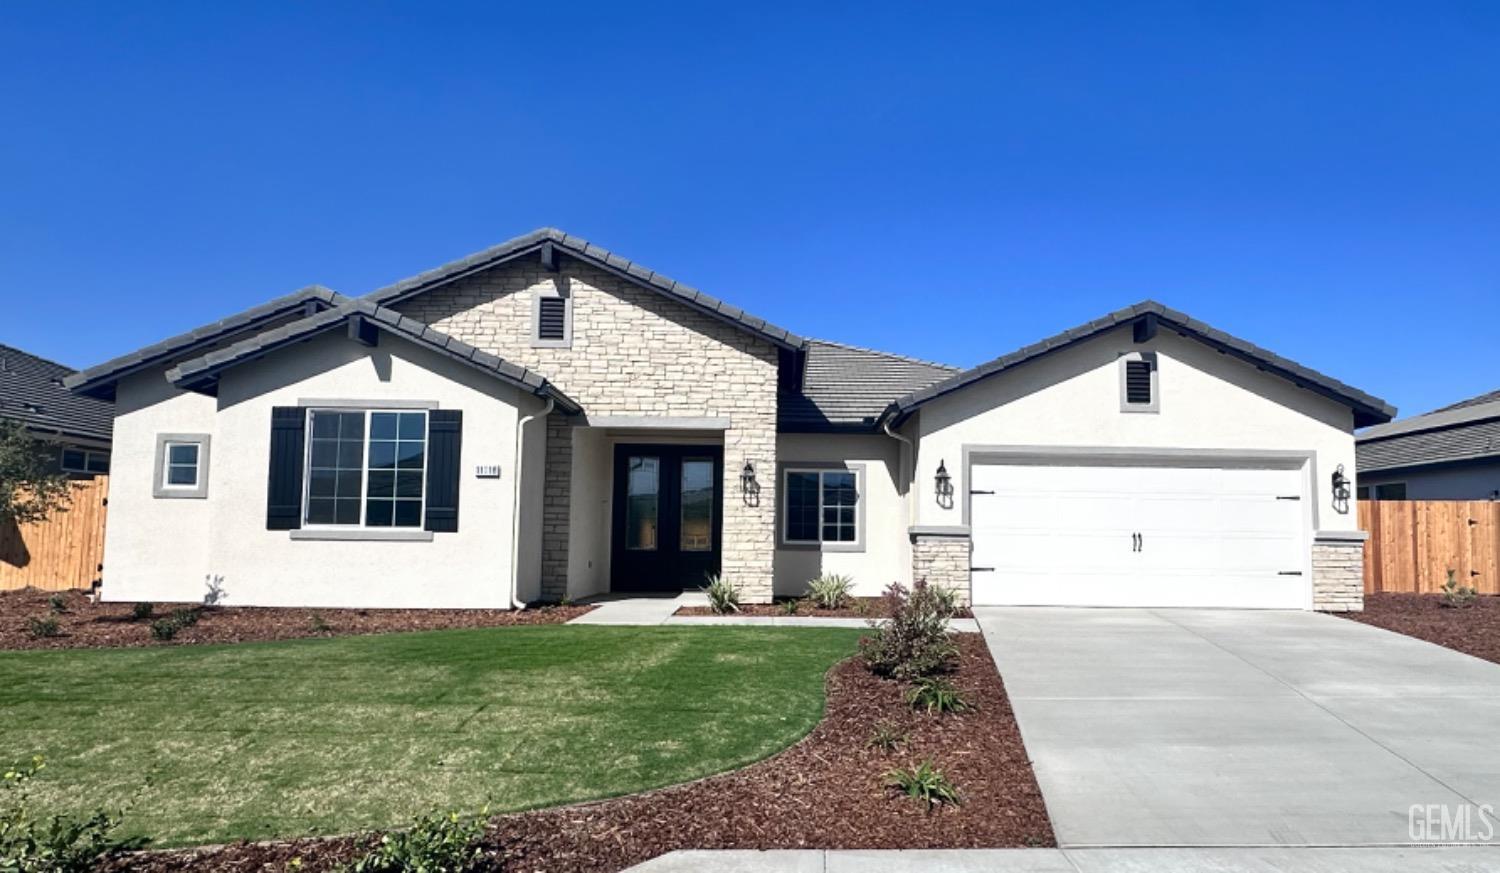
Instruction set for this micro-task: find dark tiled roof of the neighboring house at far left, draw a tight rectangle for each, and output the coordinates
[0,345,114,443]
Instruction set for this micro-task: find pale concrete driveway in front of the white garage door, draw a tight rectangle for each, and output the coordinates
[975,608,1500,848]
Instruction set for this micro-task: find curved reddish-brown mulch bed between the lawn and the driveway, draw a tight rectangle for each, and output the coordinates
[111,635,1055,873]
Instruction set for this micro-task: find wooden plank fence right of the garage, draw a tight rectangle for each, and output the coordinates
[1359,500,1500,594]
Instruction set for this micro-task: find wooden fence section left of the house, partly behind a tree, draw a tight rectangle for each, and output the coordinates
[0,476,110,591]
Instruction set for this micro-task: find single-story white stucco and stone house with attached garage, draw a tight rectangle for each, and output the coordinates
[69,228,1394,609]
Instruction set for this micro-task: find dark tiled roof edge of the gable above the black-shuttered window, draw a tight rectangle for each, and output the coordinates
[167,299,581,413]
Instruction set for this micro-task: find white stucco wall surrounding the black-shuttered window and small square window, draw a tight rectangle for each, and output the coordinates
[104,335,542,608]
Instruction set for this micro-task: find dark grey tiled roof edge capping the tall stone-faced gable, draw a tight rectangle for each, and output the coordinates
[365,228,806,350]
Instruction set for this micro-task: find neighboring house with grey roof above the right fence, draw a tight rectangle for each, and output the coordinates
[1355,392,1500,500]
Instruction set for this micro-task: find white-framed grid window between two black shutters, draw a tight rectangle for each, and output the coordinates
[303,410,428,528]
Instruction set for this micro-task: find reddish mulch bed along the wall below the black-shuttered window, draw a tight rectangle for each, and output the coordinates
[0,590,593,650]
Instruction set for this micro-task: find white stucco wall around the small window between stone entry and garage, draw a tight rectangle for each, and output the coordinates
[780,434,912,597]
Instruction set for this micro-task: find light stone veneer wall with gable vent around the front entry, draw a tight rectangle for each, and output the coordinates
[398,258,777,603]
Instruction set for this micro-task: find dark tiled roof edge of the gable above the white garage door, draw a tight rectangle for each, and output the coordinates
[884,300,1397,428]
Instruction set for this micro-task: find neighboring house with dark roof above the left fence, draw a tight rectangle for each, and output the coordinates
[0,344,114,477]
